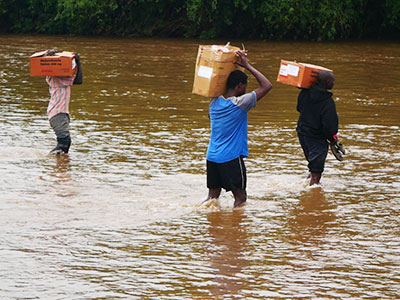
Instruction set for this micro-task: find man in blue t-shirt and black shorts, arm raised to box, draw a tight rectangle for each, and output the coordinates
[207,51,272,207]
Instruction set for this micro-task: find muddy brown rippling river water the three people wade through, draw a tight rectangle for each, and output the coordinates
[0,36,400,300]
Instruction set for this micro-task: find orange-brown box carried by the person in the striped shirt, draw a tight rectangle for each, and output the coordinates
[30,50,76,76]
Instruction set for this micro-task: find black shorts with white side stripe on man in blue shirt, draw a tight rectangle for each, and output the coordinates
[207,157,247,191]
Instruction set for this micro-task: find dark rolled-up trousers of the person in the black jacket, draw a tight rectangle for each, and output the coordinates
[298,134,329,173]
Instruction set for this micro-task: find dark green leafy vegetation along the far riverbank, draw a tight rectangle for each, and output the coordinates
[0,0,400,41]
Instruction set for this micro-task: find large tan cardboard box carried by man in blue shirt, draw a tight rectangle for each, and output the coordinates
[192,45,240,97]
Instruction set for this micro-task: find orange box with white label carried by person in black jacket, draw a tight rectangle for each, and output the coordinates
[276,60,332,88]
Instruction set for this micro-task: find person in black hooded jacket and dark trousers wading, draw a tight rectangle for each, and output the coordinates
[296,71,339,185]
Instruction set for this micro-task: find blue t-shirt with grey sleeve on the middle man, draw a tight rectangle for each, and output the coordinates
[207,91,257,163]
